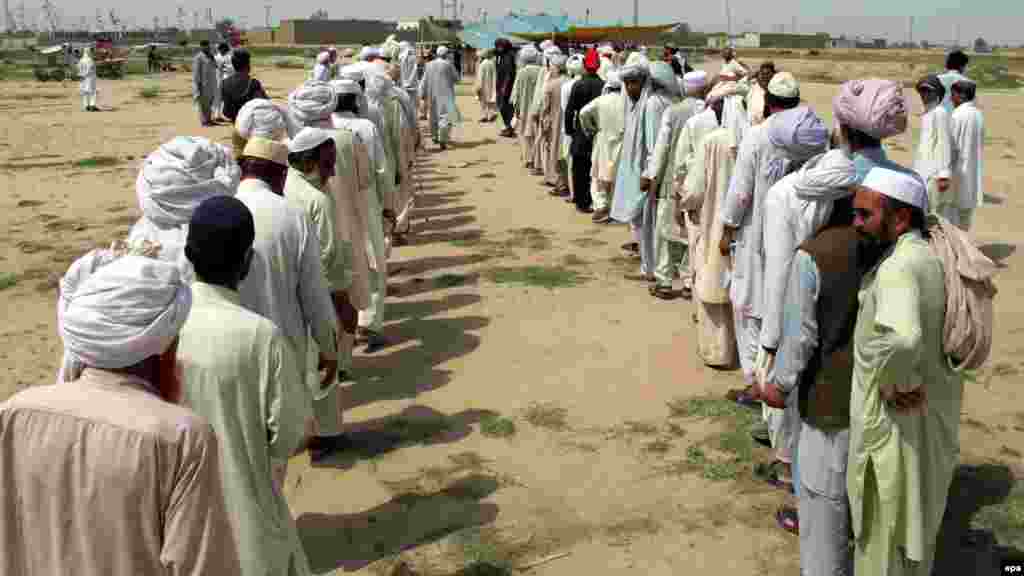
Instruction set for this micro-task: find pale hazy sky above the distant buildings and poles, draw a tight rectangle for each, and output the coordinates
[39,0,1024,45]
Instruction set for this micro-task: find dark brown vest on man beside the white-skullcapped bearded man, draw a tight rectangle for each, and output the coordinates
[798,225,863,430]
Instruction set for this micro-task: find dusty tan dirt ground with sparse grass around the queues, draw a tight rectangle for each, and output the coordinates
[0,56,1024,575]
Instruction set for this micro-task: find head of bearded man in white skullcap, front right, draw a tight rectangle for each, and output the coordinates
[853,167,928,249]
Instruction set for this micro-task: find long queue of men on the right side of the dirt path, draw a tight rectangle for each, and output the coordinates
[476,41,995,576]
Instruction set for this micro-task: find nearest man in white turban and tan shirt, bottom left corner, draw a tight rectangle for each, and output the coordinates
[0,250,242,576]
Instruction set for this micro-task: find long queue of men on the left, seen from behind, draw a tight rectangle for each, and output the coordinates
[0,39,458,576]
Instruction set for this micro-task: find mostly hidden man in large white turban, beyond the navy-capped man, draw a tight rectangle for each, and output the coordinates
[128,136,242,281]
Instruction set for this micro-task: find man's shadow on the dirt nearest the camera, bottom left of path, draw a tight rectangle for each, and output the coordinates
[296,475,499,574]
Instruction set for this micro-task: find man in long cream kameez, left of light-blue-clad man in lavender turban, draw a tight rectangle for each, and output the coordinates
[679,98,736,367]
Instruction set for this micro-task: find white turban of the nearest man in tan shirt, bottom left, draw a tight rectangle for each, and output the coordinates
[57,250,191,381]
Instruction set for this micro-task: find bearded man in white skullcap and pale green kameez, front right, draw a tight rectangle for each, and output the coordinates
[847,167,964,576]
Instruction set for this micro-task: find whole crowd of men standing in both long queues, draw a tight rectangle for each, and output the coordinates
[0,32,995,576]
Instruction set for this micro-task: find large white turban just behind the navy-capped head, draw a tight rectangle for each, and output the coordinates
[135,136,242,228]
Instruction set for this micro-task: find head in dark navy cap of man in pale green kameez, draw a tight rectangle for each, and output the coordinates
[185,196,256,290]
